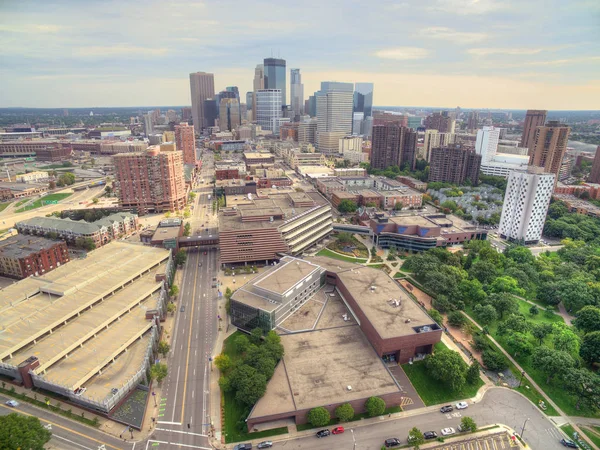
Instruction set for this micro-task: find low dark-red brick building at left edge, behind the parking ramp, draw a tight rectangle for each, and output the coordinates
[0,234,69,280]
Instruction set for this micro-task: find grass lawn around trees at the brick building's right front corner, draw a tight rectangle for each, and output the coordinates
[402,360,483,406]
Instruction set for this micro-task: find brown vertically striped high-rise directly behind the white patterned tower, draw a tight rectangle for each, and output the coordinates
[529,121,571,177]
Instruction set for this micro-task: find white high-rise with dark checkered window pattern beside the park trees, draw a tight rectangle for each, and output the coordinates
[498,167,556,244]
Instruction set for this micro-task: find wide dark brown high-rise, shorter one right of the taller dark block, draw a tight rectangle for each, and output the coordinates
[428,145,481,186]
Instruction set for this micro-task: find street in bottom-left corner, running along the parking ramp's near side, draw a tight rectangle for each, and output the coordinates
[0,395,130,450]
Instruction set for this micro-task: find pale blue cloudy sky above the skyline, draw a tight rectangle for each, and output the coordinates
[0,0,600,110]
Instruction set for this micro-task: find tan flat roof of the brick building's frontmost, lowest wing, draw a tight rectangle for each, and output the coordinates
[250,325,400,418]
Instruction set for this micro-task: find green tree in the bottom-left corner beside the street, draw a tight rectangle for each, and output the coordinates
[0,413,52,450]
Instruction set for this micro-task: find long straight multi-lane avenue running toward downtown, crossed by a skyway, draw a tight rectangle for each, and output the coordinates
[145,153,219,448]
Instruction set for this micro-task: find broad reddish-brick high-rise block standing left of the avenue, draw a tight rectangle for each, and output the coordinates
[113,145,186,215]
